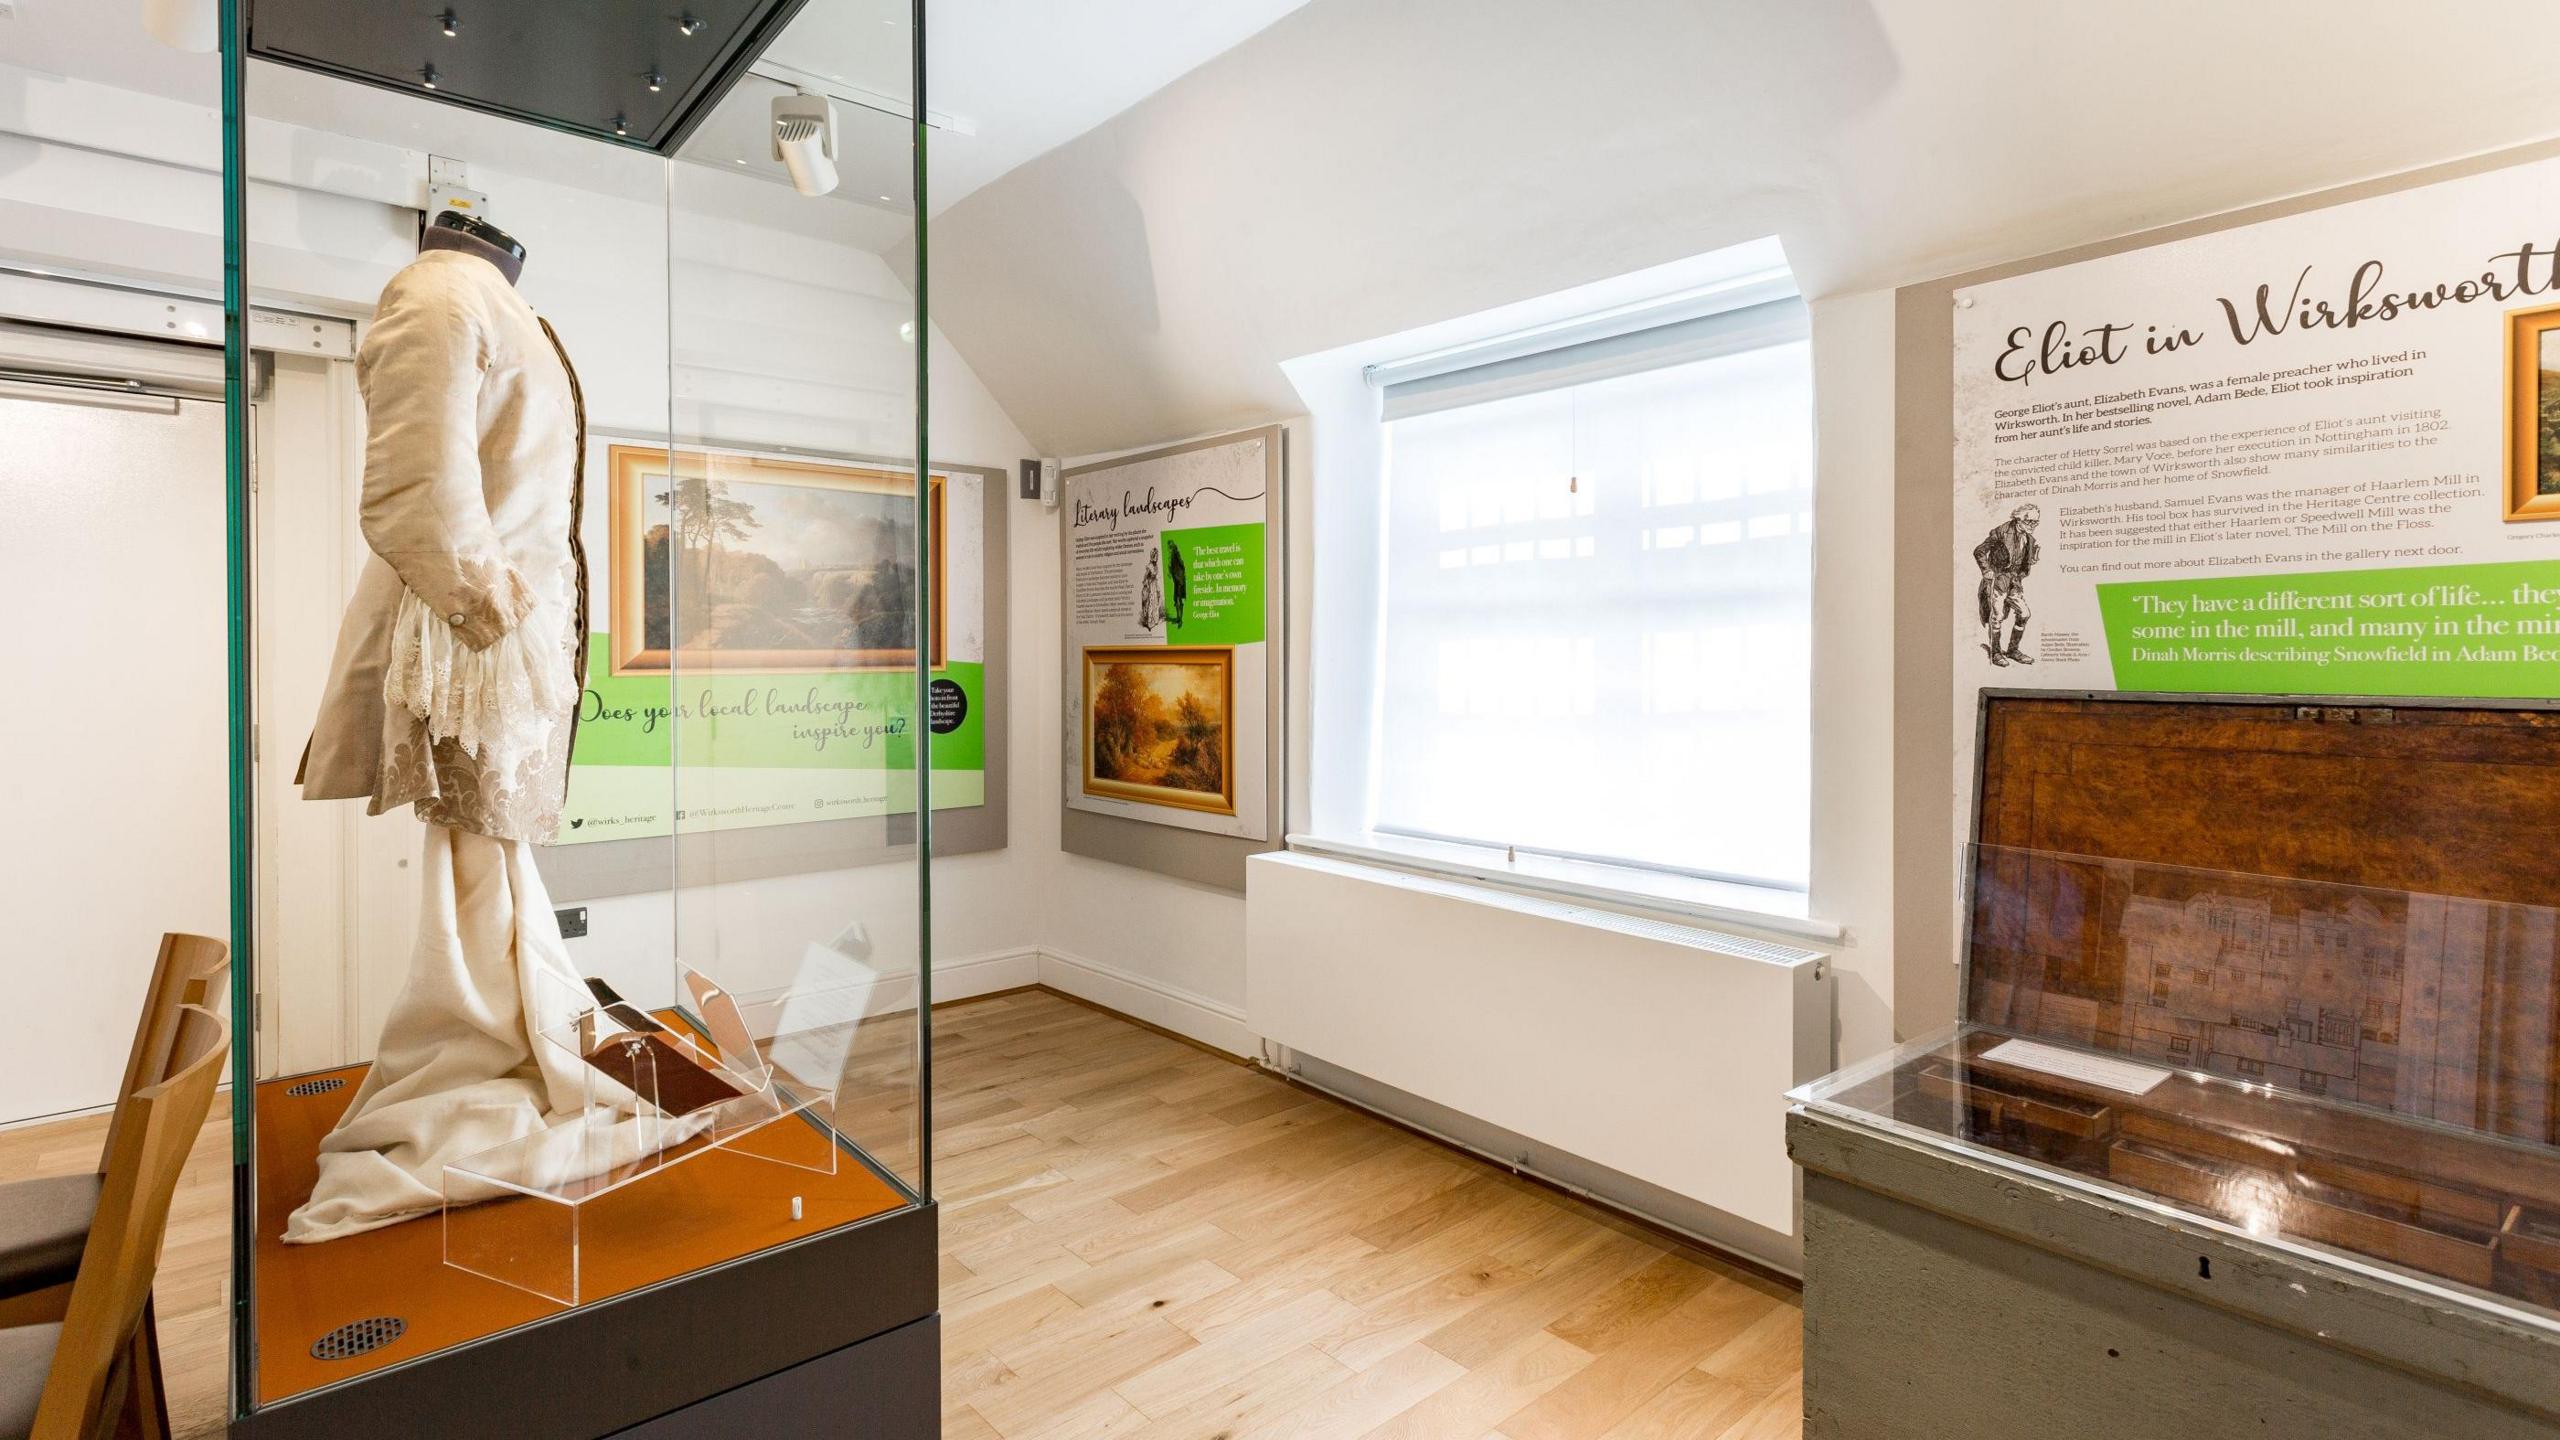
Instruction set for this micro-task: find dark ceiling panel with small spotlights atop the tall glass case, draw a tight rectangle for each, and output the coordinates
[248,0,801,154]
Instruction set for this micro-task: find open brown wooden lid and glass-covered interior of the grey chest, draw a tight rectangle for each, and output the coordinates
[1795,692,2560,1343]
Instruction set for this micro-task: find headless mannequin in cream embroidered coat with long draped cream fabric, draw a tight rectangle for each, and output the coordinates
[284,213,660,1243]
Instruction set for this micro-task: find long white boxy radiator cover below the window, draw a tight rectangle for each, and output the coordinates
[1244,853,1833,1235]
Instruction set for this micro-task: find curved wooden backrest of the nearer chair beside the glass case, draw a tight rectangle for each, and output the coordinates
[33,1004,230,1440]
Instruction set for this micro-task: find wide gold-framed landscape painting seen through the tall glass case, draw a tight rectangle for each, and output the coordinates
[604,443,950,676]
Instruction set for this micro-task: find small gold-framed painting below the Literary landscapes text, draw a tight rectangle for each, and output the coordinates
[1078,646,1236,815]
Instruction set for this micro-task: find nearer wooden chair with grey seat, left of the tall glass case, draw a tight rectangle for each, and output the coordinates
[0,1004,230,1440]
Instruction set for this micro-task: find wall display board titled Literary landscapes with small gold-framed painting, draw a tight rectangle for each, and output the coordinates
[1060,425,1285,887]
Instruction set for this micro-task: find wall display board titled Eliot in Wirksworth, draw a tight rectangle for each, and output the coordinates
[1951,161,2560,794]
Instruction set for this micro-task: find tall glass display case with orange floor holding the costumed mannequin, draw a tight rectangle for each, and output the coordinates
[223,0,952,1440]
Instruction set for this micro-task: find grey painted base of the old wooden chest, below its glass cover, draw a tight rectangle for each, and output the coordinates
[1792,1115,2560,1440]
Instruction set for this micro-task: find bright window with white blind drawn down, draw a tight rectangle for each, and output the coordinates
[1367,297,1812,892]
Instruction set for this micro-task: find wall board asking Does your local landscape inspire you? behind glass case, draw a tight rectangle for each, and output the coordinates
[543,436,1004,899]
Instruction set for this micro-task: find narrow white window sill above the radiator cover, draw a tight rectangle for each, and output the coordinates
[1288,833,1843,943]
